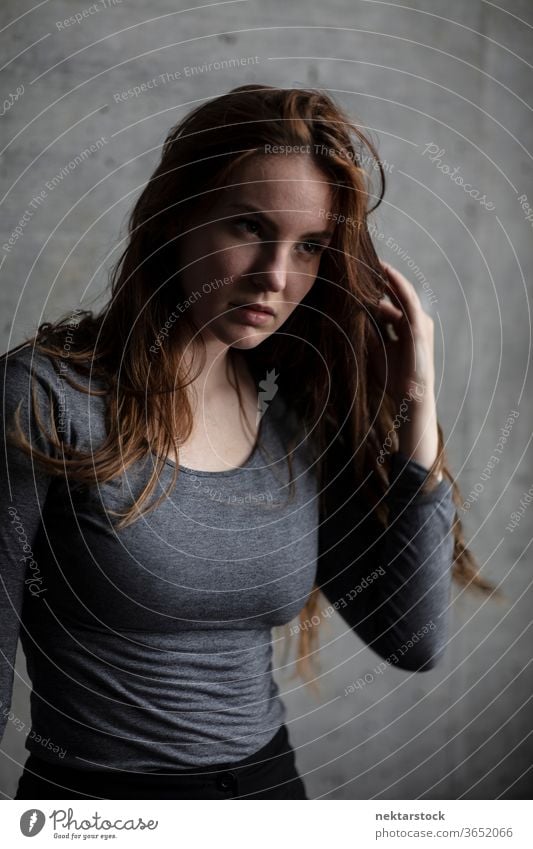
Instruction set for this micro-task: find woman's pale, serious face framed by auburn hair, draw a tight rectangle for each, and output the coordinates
[178,153,333,349]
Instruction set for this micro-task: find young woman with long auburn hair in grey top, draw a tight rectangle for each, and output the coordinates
[0,85,490,799]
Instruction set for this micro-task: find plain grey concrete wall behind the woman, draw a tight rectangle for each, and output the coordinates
[0,0,533,799]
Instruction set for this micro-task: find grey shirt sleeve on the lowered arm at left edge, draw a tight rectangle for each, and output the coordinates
[0,349,57,740]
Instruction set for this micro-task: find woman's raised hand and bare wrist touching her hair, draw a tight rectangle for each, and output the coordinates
[368,262,442,480]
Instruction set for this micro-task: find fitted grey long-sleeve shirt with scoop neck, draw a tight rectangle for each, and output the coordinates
[0,346,455,772]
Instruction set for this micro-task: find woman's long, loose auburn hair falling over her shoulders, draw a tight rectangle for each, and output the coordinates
[4,84,499,683]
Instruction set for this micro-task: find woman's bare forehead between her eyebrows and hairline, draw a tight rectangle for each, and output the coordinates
[217,153,333,217]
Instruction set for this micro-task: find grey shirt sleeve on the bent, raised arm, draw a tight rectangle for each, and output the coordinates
[317,452,455,672]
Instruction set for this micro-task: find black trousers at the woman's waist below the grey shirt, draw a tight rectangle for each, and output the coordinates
[15,724,307,799]
